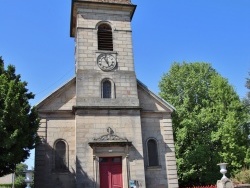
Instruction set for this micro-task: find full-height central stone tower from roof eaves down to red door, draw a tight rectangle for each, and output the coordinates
[70,0,145,188]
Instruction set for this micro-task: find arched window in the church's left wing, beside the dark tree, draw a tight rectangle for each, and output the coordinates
[55,140,67,171]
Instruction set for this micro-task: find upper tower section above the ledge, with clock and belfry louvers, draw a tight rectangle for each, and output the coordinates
[70,0,139,108]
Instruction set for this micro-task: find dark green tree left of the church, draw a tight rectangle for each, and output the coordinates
[0,57,39,177]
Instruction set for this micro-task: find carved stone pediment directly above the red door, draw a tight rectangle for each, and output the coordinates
[89,127,132,147]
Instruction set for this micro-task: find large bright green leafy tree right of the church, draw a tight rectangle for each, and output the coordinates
[159,62,248,185]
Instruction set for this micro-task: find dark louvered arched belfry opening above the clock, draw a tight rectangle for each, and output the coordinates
[98,24,113,51]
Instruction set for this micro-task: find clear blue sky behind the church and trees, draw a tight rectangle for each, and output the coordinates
[0,0,250,167]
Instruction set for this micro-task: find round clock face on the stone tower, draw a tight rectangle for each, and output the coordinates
[97,54,116,71]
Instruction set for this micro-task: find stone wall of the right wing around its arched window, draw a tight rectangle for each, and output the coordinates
[141,112,178,188]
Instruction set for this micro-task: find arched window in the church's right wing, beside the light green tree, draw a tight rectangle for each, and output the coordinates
[147,139,159,166]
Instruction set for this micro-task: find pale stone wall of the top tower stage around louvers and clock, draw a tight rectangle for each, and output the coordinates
[76,8,134,71]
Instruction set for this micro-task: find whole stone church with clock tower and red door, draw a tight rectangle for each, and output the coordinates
[34,0,178,188]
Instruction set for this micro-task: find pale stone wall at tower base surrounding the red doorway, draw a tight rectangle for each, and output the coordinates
[76,109,145,188]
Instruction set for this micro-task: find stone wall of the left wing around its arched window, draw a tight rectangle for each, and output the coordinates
[35,114,76,188]
